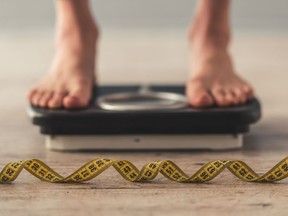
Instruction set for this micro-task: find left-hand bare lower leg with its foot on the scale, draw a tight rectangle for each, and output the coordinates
[28,0,98,108]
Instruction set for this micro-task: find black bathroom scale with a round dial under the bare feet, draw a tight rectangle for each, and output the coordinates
[28,85,261,150]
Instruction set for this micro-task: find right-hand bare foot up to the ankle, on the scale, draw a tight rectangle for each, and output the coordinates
[186,28,253,108]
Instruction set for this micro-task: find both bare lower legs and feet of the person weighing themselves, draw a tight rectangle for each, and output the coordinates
[27,0,254,109]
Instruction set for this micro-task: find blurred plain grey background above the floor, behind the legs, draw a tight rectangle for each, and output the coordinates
[0,0,288,33]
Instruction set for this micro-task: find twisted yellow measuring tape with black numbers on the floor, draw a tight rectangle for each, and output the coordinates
[0,157,288,183]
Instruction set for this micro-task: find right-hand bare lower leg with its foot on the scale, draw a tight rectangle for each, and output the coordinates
[186,0,253,107]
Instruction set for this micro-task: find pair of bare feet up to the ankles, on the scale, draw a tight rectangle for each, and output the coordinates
[28,19,253,109]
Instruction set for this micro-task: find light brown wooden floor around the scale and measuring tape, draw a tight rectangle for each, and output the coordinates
[0,30,288,216]
